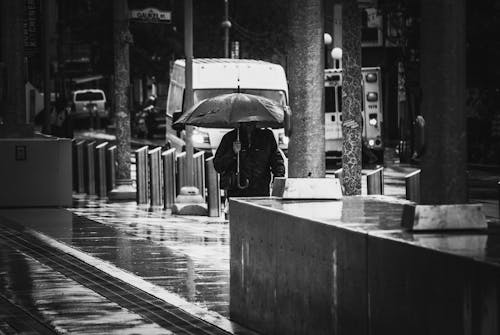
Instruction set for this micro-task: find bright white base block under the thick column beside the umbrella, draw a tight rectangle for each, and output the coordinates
[272,177,342,200]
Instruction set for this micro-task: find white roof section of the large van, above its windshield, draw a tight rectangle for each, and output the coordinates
[171,58,288,95]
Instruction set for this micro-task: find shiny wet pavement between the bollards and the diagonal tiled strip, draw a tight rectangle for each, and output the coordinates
[2,199,229,317]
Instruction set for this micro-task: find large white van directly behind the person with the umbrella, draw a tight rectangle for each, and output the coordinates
[166,58,288,152]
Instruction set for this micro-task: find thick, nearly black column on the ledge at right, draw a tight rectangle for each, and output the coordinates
[420,0,467,204]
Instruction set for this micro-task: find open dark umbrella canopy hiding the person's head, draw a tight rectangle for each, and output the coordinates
[173,93,288,129]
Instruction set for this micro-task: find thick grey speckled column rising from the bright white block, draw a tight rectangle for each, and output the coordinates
[287,0,325,178]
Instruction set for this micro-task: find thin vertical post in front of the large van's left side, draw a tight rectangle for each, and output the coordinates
[184,0,193,186]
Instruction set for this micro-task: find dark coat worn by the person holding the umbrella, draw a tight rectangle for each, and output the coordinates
[214,128,285,196]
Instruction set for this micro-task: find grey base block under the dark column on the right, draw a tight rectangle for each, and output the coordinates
[402,204,488,230]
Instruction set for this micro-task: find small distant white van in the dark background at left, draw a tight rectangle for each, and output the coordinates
[73,89,108,119]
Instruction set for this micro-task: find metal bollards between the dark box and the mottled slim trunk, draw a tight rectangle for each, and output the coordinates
[73,140,116,199]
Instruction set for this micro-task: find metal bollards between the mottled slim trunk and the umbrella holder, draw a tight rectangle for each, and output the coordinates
[135,146,221,217]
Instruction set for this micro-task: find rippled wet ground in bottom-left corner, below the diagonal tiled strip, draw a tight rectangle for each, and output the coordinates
[0,243,171,334]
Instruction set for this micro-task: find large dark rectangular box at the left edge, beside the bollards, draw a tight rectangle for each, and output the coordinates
[0,137,72,207]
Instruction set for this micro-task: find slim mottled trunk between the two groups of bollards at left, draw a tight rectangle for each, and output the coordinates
[113,0,132,182]
